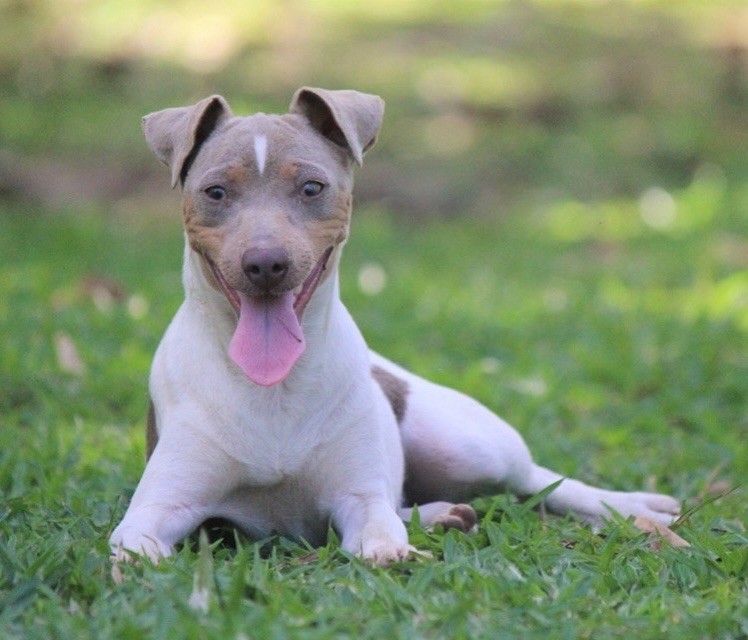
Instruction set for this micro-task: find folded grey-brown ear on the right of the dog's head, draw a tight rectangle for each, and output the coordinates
[290,87,384,165]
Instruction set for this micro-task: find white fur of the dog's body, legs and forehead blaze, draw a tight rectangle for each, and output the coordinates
[110,89,678,564]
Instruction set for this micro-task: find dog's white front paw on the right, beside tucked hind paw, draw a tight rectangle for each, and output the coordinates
[332,493,415,566]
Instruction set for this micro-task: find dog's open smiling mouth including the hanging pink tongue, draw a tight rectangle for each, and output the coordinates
[204,247,333,387]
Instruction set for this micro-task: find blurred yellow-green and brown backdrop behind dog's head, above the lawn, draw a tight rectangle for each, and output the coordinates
[0,0,748,219]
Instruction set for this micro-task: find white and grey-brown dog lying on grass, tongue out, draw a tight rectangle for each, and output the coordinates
[110,87,679,565]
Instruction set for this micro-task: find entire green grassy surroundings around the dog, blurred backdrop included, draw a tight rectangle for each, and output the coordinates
[0,0,748,640]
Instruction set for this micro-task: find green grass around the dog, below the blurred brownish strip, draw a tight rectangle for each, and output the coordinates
[0,176,748,640]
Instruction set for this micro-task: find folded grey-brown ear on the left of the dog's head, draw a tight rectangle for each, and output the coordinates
[143,96,232,189]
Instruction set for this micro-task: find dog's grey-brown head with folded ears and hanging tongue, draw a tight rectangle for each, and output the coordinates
[143,87,384,385]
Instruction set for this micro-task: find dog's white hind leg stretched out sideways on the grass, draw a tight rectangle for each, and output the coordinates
[373,356,679,523]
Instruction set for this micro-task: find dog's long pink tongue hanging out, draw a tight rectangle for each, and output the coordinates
[229,292,306,387]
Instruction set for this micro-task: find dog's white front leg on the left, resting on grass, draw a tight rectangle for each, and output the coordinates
[109,442,225,562]
